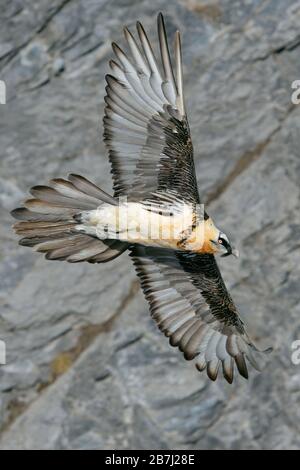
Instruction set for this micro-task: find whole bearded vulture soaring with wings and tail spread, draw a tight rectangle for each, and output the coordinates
[12,14,269,383]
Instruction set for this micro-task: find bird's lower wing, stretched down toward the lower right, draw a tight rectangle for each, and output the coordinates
[131,246,268,383]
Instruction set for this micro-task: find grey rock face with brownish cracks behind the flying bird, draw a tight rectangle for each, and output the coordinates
[0,0,300,449]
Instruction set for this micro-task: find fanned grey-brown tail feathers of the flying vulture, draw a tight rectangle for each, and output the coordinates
[11,174,128,263]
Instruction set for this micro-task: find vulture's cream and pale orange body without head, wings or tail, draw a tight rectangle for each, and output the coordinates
[76,201,220,253]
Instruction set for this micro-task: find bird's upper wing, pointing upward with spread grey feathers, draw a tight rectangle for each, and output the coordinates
[104,14,199,203]
